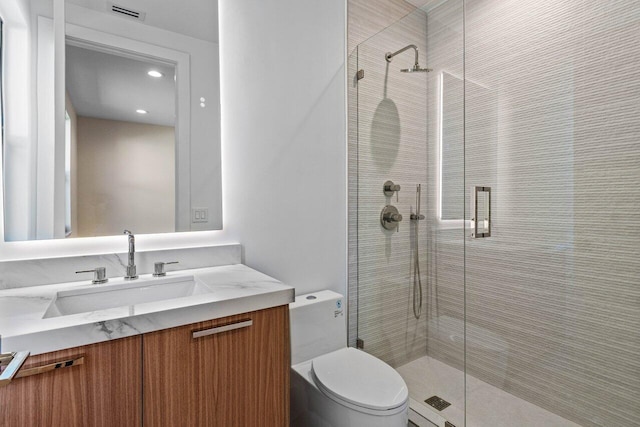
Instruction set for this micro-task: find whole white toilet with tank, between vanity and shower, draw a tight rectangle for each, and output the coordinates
[289,291,409,427]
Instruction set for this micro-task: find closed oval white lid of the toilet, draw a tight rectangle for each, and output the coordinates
[311,347,409,411]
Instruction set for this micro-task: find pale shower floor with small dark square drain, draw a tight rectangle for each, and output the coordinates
[397,356,580,427]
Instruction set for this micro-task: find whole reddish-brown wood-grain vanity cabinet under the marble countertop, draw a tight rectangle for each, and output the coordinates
[0,305,290,427]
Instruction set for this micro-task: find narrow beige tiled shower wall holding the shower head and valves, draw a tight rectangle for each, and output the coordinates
[348,1,427,365]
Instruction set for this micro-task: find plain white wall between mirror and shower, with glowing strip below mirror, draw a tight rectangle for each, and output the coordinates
[0,0,347,293]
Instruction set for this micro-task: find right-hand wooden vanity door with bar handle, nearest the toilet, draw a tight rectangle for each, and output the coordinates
[143,306,290,427]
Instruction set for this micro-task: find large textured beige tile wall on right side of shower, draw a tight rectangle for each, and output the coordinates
[427,0,640,426]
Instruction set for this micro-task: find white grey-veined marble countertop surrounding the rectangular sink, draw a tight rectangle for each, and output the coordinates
[0,264,295,355]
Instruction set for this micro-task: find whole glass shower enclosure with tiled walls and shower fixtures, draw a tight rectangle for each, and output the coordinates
[349,0,640,427]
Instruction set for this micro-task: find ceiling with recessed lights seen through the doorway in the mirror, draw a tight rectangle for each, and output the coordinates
[66,44,176,126]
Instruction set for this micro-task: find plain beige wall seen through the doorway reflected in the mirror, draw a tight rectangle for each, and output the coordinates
[72,116,175,237]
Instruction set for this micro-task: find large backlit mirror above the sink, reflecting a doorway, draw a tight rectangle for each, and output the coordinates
[0,0,222,241]
